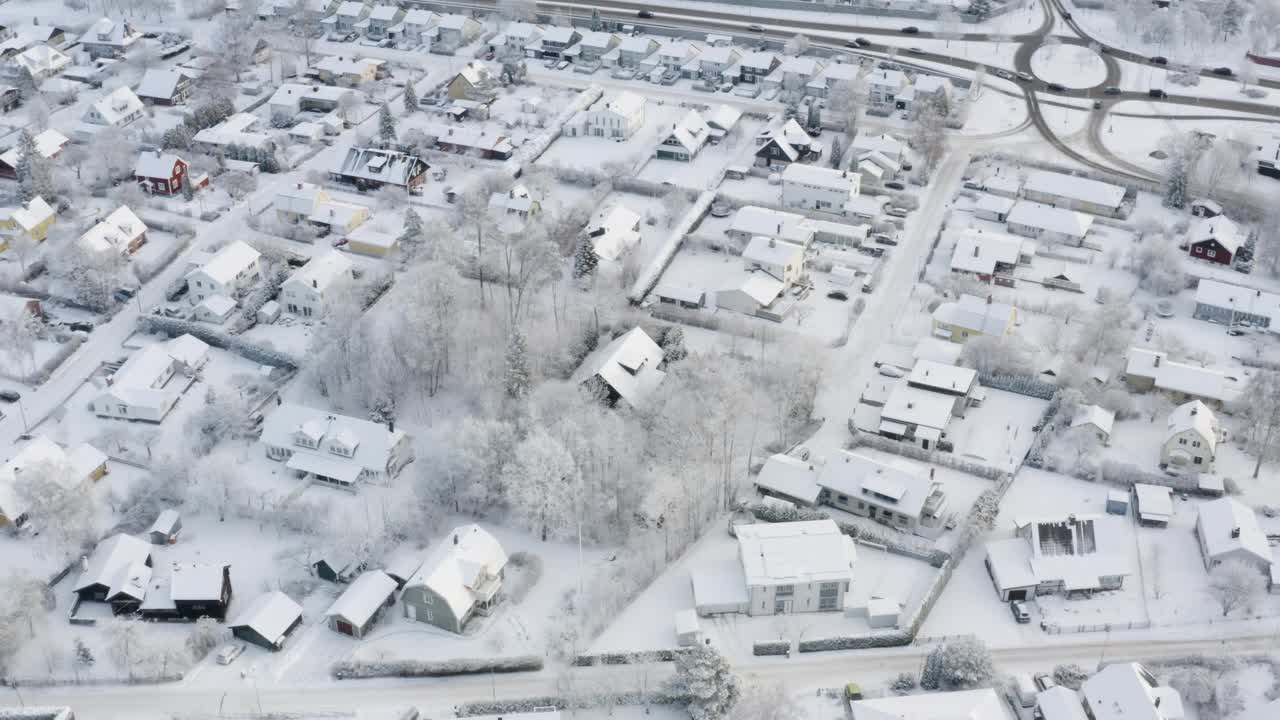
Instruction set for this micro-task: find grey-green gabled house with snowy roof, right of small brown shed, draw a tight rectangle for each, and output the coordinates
[401,524,507,634]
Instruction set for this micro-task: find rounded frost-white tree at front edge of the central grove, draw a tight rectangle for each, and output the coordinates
[502,428,581,541]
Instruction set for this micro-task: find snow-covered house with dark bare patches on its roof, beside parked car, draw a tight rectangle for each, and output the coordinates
[986,515,1133,602]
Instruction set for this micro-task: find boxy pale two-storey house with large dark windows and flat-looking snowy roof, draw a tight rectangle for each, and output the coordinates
[732,520,858,616]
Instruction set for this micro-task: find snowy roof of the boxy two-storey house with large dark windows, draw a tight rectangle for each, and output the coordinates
[736,520,858,588]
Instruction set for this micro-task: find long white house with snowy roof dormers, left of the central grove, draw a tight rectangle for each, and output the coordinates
[260,402,413,488]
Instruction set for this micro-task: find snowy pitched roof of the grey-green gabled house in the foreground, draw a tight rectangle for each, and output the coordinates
[404,524,507,618]
